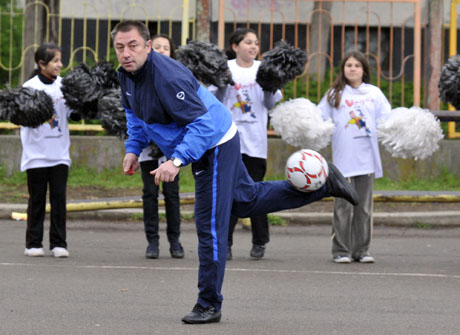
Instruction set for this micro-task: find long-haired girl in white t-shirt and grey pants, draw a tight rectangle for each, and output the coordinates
[318,51,391,263]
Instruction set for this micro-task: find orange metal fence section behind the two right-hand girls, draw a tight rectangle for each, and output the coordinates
[217,0,422,106]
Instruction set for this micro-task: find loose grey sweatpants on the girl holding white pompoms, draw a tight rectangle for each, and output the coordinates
[332,174,374,260]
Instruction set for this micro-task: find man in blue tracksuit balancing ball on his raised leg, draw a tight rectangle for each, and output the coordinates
[112,21,358,323]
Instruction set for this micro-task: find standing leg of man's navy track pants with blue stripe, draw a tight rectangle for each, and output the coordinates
[192,136,241,310]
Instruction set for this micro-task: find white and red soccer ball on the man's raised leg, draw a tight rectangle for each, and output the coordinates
[285,149,329,192]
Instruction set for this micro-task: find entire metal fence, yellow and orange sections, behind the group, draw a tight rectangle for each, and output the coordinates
[0,0,444,120]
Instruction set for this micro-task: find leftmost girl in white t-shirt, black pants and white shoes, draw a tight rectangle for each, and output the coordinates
[21,43,77,257]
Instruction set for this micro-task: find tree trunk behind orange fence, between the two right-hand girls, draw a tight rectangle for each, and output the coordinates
[308,1,332,80]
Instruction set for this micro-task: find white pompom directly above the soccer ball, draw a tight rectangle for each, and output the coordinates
[270,98,334,150]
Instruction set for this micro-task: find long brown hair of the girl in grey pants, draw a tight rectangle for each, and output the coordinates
[327,51,371,108]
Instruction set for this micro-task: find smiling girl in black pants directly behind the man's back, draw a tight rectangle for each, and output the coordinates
[209,28,282,260]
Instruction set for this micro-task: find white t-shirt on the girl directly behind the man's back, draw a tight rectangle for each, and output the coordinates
[208,59,282,159]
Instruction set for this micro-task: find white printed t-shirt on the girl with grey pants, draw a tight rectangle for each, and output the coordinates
[318,83,391,178]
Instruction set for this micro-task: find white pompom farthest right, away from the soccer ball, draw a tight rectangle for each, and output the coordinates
[378,107,444,160]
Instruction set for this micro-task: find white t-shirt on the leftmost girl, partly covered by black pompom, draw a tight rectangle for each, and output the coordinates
[21,75,72,171]
